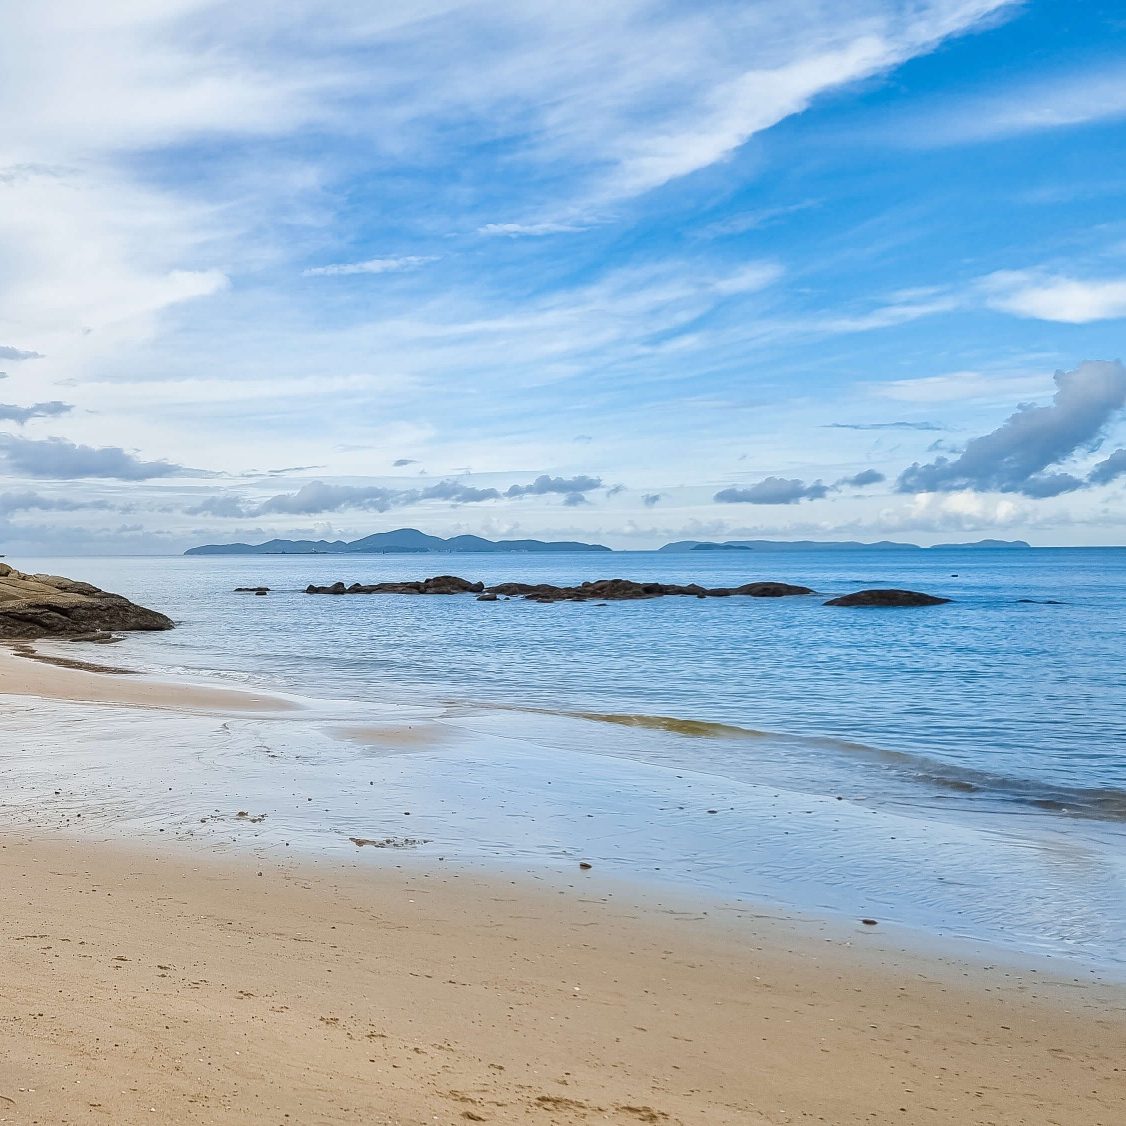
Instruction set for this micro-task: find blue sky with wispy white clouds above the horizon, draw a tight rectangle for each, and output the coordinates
[0,0,1126,558]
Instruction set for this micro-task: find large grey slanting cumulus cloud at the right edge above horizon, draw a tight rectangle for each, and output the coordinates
[896,360,1126,498]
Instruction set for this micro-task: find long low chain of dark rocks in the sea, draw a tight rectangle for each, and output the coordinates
[305,574,813,602]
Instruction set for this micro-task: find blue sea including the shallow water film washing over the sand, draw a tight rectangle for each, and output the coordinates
[0,548,1126,976]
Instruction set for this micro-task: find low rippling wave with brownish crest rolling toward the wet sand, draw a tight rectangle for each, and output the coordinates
[558,708,1126,821]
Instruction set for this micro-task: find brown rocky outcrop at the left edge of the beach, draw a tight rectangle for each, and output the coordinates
[0,563,173,641]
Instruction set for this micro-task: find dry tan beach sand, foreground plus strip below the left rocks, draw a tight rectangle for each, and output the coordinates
[0,658,1126,1126]
